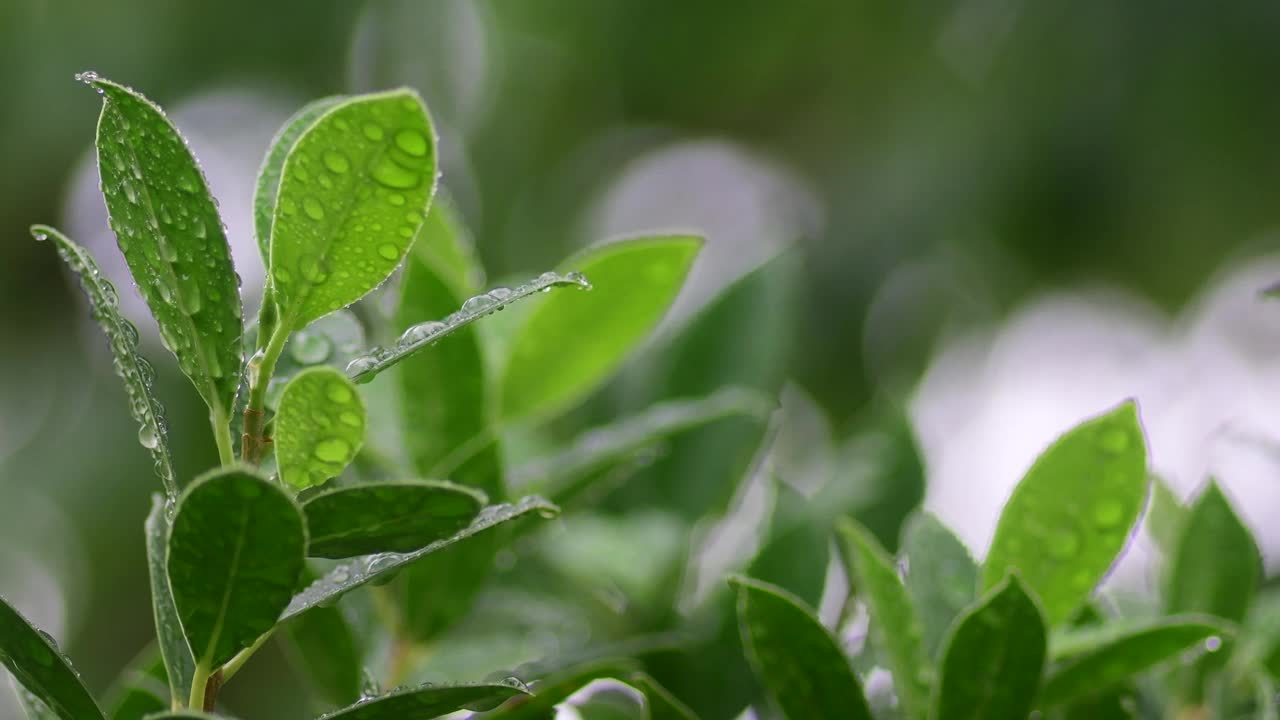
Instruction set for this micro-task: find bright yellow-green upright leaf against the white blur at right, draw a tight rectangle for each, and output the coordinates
[982,401,1147,625]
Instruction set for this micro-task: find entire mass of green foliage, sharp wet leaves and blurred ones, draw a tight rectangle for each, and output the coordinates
[0,73,1280,720]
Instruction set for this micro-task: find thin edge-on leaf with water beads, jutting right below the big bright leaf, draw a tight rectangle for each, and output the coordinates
[347,273,591,383]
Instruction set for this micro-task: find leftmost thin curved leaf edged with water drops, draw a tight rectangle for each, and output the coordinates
[31,225,178,500]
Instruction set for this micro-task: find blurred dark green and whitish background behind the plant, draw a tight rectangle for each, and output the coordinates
[0,0,1280,720]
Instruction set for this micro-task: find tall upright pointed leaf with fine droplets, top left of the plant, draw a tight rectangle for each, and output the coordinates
[82,73,243,423]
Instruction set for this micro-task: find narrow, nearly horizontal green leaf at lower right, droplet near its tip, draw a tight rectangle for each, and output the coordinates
[1041,618,1228,706]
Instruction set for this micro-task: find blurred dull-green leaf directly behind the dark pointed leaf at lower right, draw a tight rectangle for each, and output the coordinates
[902,512,978,657]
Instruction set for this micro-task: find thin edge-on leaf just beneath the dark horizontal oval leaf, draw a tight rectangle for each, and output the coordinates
[280,497,559,623]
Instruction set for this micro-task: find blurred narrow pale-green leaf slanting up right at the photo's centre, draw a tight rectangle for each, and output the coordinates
[511,387,772,503]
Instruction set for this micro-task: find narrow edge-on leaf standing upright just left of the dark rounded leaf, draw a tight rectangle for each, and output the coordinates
[146,495,196,702]
